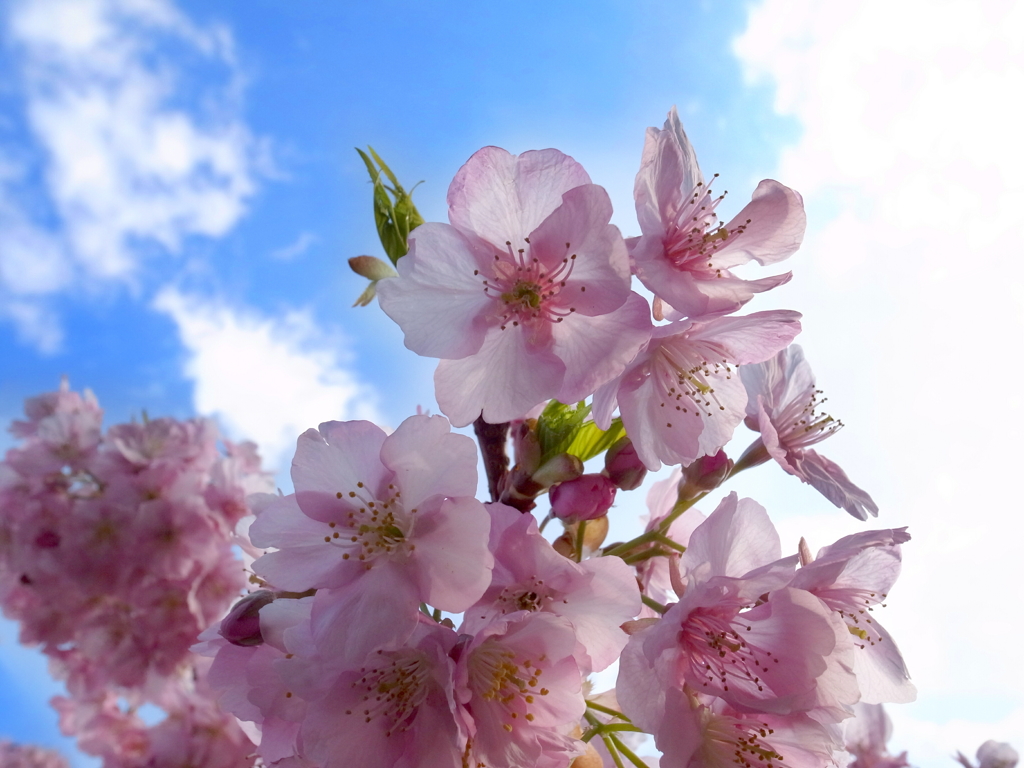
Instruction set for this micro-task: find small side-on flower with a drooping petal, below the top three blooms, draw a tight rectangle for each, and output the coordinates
[739,344,879,520]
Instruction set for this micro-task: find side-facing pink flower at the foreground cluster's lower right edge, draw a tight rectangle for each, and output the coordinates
[793,528,918,703]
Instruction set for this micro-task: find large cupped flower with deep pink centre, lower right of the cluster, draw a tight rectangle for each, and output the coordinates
[615,494,859,723]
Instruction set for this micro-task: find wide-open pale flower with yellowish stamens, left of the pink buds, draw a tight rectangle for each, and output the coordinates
[249,416,494,663]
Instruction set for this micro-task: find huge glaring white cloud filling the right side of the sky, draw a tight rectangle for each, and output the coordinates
[735,0,1024,765]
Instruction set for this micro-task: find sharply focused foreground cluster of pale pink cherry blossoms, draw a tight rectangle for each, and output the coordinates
[192,111,915,768]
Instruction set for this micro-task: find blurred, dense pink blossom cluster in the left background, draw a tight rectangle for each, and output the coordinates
[0,382,268,768]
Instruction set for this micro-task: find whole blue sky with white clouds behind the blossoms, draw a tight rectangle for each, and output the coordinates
[0,0,1024,767]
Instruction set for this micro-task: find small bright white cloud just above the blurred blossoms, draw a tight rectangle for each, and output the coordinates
[155,289,380,470]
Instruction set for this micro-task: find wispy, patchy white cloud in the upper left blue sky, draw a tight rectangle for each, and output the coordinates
[0,0,261,348]
